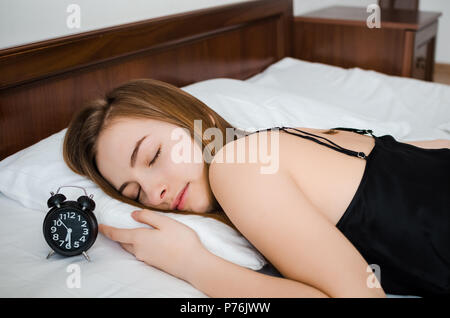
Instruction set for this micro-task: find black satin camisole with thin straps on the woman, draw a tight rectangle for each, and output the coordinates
[256,127,450,297]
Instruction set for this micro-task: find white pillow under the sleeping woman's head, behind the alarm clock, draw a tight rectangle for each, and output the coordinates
[0,128,267,270]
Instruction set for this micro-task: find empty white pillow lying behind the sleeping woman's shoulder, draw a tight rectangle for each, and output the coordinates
[182,78,411,139]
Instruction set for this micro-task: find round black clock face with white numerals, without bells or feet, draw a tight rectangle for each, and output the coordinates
[44,207,97,256]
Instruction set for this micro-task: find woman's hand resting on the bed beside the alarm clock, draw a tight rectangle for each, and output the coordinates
[99,209,206,280]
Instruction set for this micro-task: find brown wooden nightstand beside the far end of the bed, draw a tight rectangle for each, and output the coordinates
[292,6,441,81]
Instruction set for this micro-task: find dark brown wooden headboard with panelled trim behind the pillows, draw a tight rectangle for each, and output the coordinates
[0,0,293,160]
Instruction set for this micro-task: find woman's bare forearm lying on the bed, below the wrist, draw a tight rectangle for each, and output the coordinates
[187,249,328,298]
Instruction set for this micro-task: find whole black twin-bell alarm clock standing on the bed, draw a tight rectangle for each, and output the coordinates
[43,186,98,261]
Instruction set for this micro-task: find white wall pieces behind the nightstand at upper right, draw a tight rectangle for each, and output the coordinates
[294,0,450,64]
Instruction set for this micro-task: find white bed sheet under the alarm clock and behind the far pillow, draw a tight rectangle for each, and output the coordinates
[0,58,450,297]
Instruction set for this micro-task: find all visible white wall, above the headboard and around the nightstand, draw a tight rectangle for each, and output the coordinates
[0,0,450,64]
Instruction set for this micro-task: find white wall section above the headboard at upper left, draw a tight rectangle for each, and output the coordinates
[0,0,249,49]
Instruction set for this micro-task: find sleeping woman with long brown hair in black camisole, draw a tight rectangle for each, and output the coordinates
[64,79,450,297]
